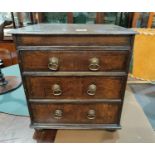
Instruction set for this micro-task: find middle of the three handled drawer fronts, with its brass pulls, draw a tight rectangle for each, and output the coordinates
[26,76,125,99]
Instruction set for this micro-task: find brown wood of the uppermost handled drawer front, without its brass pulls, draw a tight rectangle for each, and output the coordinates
[21,51,128,71]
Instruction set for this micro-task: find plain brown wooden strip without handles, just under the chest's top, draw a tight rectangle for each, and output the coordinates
[16,35,130,46]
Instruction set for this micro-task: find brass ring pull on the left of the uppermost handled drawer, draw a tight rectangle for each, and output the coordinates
[48,57,59,71]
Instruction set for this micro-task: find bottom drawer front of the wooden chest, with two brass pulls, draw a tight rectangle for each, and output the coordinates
[31,103,121,124]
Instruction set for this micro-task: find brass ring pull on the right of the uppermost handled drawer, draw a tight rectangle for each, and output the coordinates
[89,58,100,71]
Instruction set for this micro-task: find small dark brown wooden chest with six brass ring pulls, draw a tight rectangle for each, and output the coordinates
[12,24,135,142]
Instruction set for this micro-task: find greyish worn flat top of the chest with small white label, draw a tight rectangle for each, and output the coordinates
[11,24,135,36]
